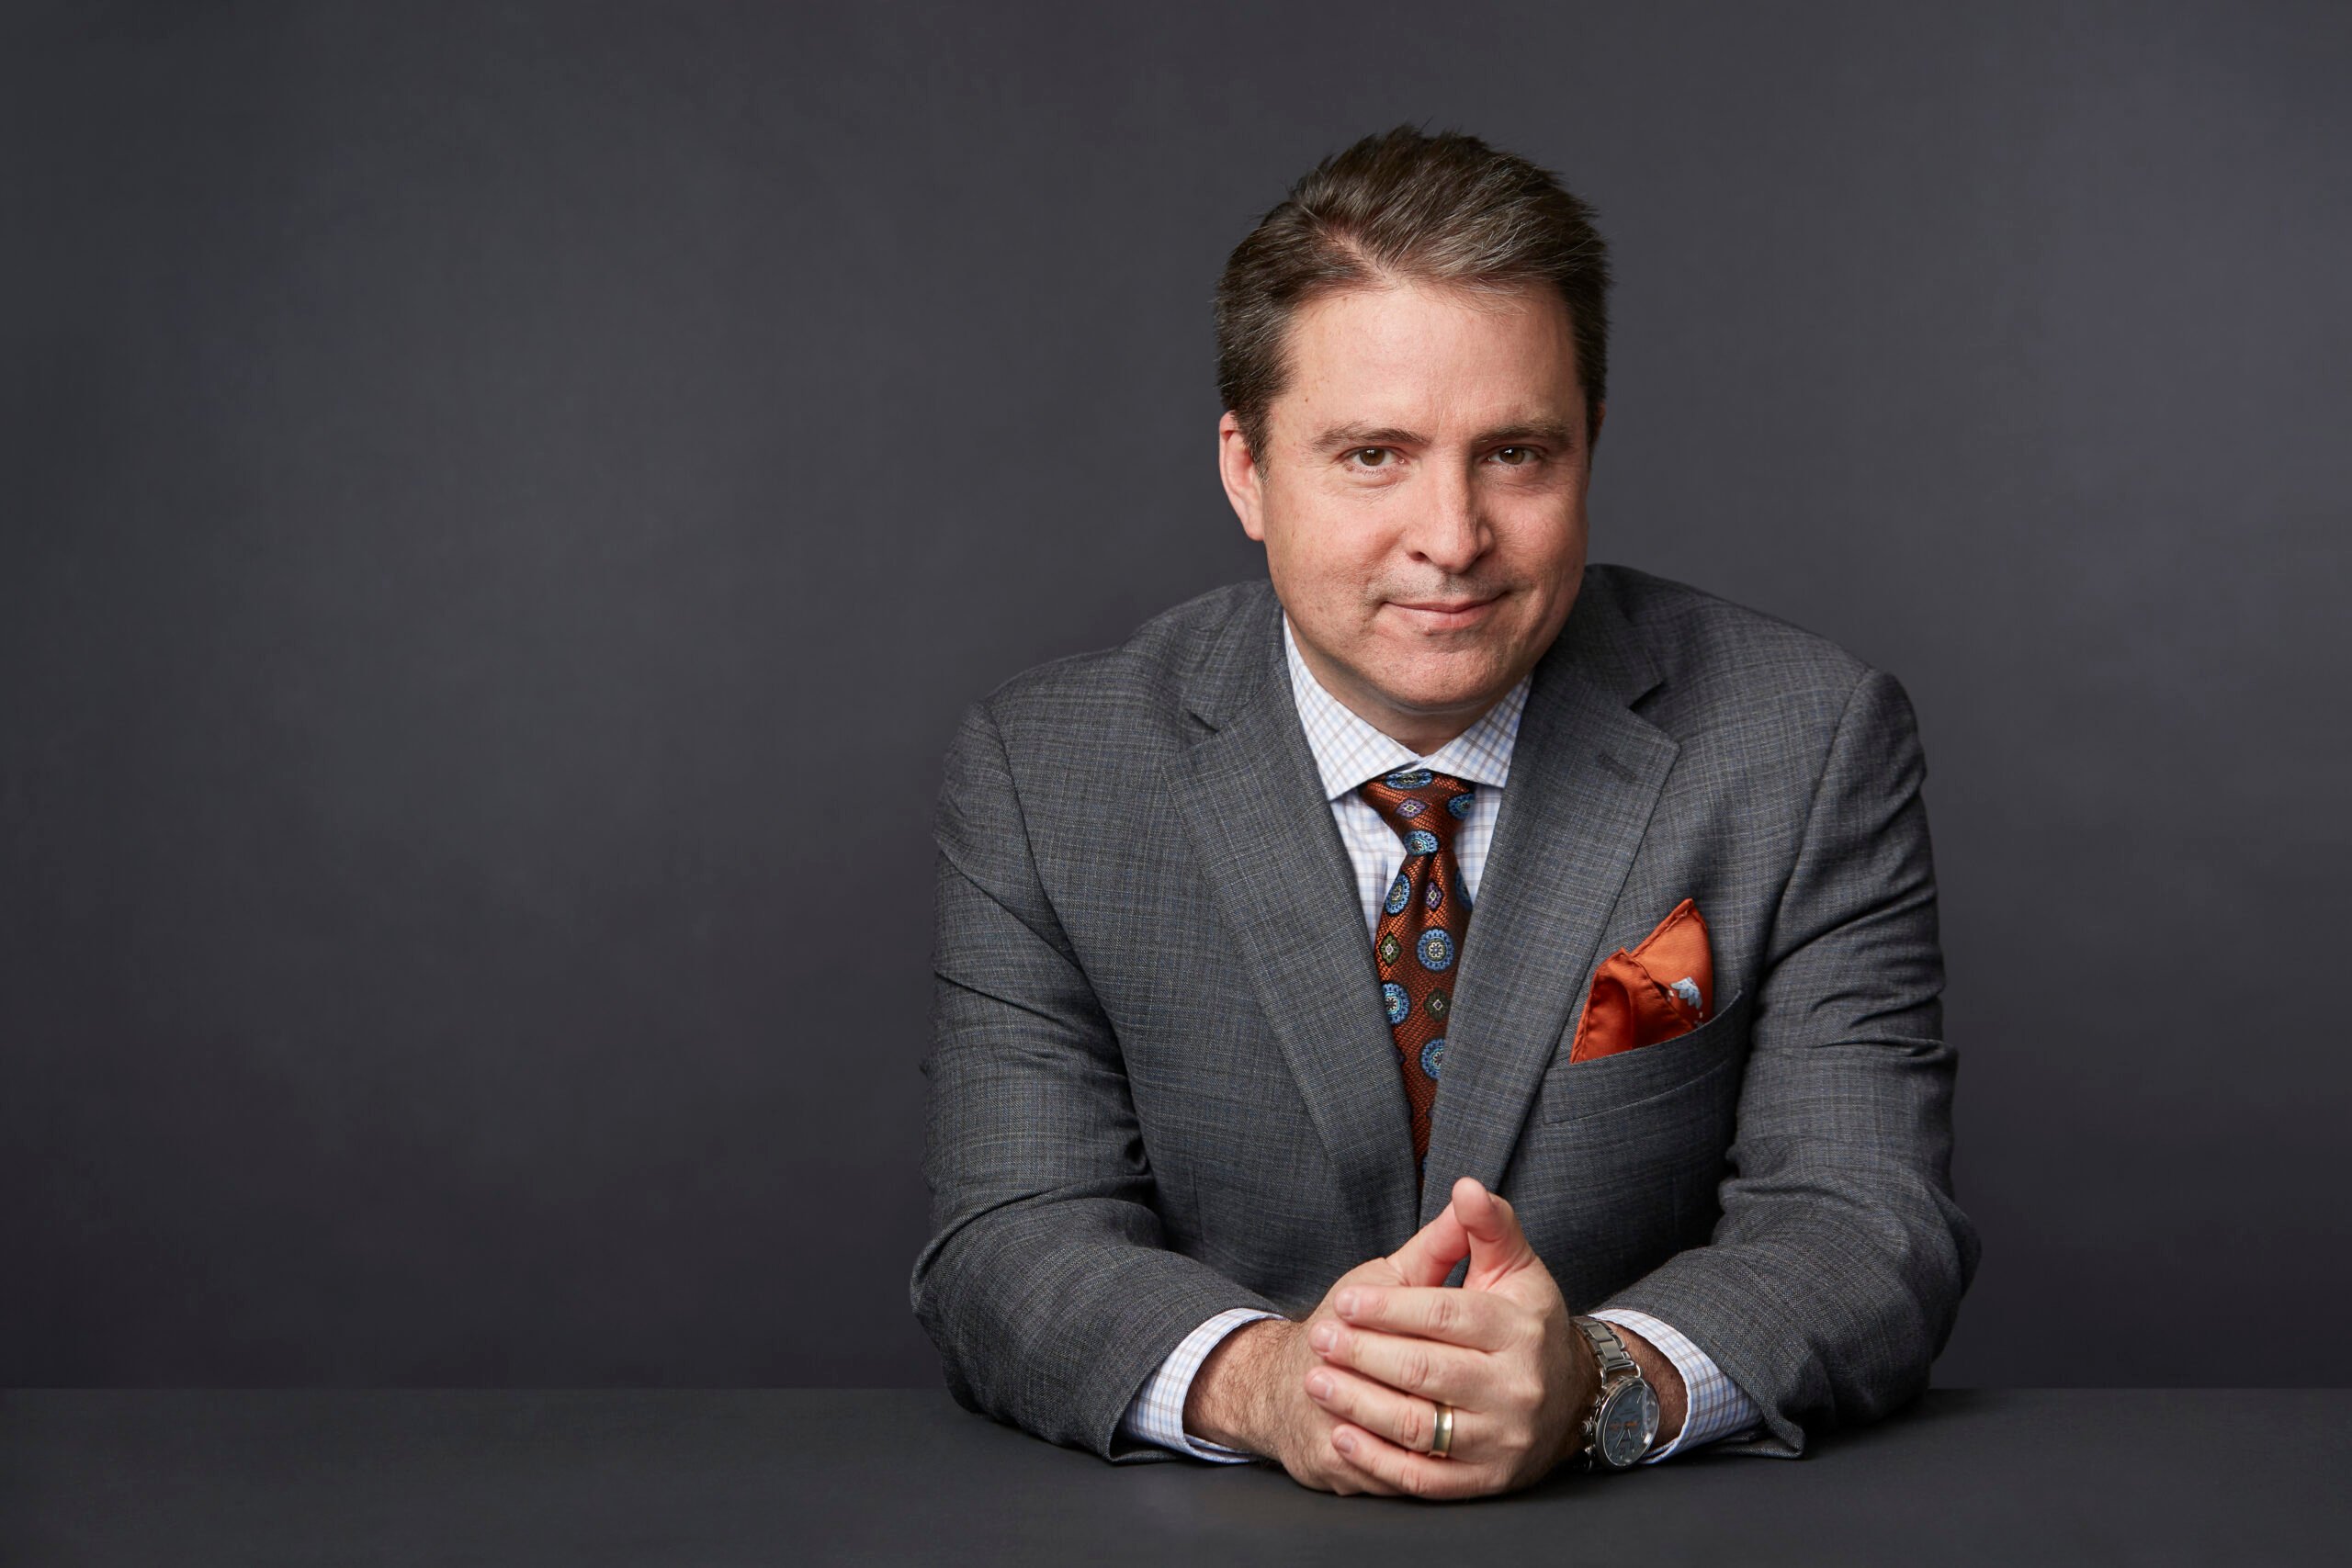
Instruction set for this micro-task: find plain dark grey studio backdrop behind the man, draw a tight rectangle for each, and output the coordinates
[0,0,2352,1384]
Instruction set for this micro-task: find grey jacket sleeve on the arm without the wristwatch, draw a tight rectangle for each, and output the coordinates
[908,703,1282,1462]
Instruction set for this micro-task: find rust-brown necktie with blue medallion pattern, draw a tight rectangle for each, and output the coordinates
[1357,769,1477,1176]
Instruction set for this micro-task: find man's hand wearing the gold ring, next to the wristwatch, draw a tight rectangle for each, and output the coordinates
[1307,1176,1600,1497]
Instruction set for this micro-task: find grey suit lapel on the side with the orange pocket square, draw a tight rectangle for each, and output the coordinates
[1411,569,1681,1224]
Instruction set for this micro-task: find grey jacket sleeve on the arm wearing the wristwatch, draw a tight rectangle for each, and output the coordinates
[1606,670,1978,1458]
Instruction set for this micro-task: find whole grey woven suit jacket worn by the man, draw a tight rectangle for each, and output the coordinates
[910,567,1978,1460]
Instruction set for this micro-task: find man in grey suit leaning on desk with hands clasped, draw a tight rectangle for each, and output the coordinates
[910,127,1978,1497]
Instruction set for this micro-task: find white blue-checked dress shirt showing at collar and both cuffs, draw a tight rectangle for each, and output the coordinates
[1120,616,1759,1464]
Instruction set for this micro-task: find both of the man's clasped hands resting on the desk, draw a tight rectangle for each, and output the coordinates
[1188,1176,1636,1497]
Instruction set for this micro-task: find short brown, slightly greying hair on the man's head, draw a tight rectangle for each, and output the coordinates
[1216,125,1609,461]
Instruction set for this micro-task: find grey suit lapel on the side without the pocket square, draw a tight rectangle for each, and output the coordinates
[1169,585,1420,1258]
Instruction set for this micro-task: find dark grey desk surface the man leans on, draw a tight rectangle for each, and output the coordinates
[0,1389,2352,1568]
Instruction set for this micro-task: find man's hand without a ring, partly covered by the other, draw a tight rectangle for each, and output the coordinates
[1183,1203,1470,1495]
